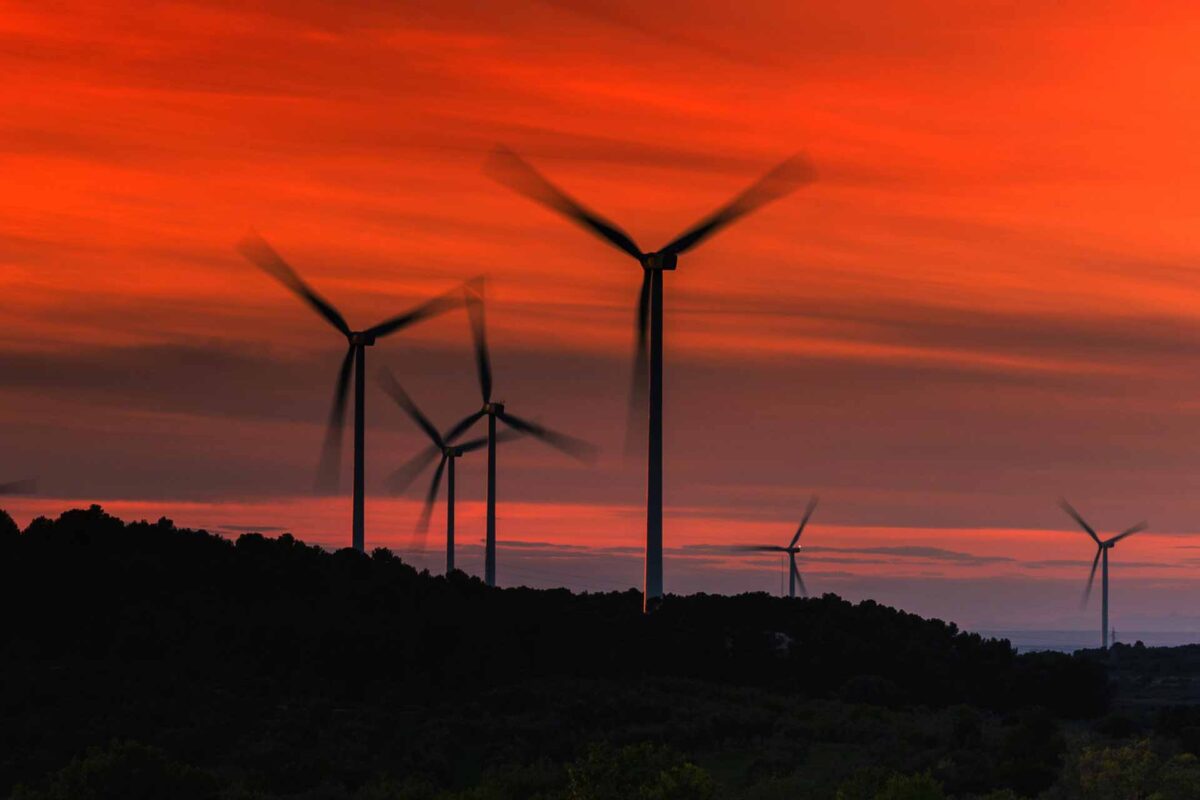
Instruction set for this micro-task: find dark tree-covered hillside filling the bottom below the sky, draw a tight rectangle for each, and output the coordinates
[0,506,1200,800]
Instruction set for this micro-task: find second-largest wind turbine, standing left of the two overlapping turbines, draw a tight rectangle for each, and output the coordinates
[238,231,462,552]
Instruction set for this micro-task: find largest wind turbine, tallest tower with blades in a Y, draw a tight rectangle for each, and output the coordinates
[488,148,814,612]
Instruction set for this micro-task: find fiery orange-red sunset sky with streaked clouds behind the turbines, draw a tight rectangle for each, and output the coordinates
[0,0,1200,633]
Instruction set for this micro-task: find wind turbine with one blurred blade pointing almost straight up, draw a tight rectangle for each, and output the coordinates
[444,281,595,587]
